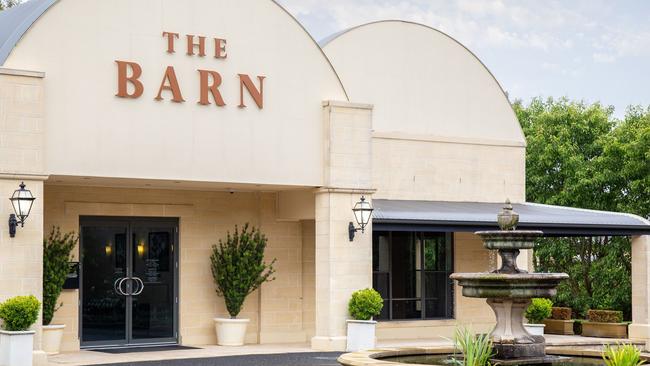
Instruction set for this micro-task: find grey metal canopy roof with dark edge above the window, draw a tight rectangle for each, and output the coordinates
[372,199,650,236]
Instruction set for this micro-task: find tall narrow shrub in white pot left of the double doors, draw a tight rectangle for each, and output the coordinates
[42,227,77,354]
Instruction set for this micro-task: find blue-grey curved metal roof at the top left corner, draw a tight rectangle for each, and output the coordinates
[0,0,58,65]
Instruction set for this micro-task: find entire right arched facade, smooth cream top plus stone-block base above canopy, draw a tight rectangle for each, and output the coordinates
[323,21,525,202]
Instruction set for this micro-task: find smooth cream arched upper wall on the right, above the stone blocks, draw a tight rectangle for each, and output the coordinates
[323,21,524,145]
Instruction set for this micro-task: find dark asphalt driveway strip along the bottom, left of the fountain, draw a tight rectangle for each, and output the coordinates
[93,352,341,366]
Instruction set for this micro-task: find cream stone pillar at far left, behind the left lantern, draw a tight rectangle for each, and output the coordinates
[0,68,47,365]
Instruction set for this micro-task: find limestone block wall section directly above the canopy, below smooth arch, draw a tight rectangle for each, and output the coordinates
[372,133,526,202]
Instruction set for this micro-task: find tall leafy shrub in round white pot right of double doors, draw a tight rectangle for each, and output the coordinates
[210,224,275,346]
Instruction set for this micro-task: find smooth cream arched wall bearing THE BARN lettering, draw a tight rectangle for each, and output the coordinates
[4,0,347,186]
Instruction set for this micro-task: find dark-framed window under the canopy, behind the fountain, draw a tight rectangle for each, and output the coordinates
[372,231,454,320]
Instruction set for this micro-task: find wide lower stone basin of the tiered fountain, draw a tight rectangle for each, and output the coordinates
[449,272,569,299]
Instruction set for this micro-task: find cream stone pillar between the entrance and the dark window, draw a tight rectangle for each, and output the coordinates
[311,102,374,351]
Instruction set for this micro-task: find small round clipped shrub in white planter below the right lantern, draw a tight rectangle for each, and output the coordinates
[347,288,384,352]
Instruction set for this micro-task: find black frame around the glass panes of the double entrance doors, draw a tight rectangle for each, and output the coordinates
[78,216,180,349]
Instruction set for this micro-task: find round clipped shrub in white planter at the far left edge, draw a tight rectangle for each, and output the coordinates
[0,295,41,366]
